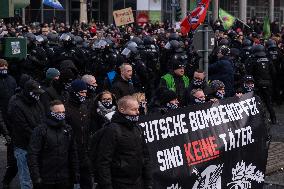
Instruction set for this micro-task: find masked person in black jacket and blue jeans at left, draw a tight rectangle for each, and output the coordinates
[9,80,45,189]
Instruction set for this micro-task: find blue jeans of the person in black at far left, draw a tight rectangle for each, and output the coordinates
[14,147,33,189]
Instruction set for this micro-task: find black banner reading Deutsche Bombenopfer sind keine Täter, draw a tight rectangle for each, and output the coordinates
[140,93,267,189]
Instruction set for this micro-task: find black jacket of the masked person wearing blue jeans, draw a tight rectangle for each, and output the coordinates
[8,93,46,150]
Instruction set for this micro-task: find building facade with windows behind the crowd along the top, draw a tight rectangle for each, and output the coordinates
[23,0,284,24]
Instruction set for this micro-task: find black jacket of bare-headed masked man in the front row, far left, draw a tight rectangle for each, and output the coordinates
[28,119,79,184]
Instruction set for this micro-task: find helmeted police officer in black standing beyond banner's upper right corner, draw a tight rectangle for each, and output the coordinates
[248,45,276,124]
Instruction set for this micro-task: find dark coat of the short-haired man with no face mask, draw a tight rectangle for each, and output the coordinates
[111,76,135,100]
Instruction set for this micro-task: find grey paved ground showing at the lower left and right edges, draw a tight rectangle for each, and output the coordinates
[0,105,284,189]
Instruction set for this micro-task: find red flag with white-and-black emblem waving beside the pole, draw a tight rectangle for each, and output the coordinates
[180,0,210,35]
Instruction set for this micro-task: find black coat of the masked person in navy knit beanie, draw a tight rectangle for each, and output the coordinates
[65,97,91,163]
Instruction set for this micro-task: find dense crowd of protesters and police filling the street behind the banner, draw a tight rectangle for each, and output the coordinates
[0,16,284,189]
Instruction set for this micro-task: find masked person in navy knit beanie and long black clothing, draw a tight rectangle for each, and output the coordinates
[65,79,92,189]
